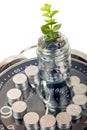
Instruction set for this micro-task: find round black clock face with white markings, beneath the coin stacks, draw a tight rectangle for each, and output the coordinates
[0,58,87,130]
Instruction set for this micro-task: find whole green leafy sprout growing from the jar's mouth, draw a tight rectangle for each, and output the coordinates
[41,4,61,43]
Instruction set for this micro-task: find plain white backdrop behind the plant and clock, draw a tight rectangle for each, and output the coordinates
[0,0,87,62]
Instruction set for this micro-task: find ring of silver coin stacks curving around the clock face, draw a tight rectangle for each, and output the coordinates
[0,66,87,130]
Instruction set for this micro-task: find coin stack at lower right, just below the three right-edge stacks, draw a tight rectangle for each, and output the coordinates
[66,104,82,120]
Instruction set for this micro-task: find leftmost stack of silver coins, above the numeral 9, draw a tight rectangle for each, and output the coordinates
[7,88,22,105]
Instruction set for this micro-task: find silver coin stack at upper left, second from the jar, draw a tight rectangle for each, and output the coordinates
[13,73,28,91]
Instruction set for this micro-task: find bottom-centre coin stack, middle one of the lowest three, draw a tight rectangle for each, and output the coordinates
[40,114,56,130]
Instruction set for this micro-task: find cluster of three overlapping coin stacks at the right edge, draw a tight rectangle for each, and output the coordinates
[70,76,87,109]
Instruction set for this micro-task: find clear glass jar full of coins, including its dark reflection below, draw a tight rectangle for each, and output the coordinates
[37,33,71,108]
